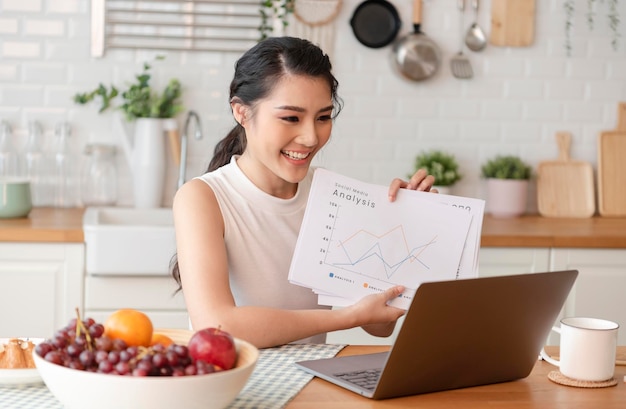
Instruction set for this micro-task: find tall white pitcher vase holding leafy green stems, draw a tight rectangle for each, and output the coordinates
[122,118,166,208]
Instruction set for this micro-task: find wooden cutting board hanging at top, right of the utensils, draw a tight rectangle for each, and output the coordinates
[489,0,535,47]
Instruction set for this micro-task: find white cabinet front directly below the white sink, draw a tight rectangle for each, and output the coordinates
[85,275,189,328]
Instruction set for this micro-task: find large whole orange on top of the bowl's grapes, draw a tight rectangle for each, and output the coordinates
[104,309,152,347]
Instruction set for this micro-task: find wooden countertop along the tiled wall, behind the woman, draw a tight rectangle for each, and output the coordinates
[0,208,626,248]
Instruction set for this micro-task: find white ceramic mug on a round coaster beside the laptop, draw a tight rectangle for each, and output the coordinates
[541,317,619,382]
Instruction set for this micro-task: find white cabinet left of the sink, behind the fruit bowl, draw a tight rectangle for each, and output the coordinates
[0,242,85,338]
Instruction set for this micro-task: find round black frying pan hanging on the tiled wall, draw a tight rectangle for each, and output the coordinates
[350,0,402,48]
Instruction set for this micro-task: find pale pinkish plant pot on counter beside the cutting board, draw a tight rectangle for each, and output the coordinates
[487,179,528,218]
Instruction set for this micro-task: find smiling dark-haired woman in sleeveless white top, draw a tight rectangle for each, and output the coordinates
[173,37,434,348]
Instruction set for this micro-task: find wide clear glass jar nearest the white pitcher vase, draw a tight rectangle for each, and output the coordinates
[81,144,117,206]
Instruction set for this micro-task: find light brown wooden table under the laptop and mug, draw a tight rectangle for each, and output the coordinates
[287,346,626,409]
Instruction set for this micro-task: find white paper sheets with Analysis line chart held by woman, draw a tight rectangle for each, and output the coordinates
[289,169,484,309]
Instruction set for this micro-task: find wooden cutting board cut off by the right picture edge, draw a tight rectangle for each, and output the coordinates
[598,102,626,217]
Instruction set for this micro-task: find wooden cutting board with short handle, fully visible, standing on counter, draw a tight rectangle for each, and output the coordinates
[537,132,596,218]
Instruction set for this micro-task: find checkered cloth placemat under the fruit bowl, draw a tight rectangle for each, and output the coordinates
[0,344,345,409]
